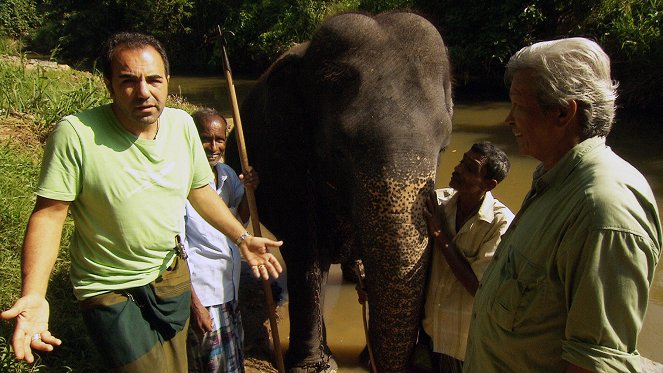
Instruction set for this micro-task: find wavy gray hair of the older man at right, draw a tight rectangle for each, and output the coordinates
[504,37,618,139]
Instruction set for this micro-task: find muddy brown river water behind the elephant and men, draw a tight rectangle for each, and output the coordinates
[170,76,663,372]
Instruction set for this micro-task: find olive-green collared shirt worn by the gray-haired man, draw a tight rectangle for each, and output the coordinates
[464,138,661,373]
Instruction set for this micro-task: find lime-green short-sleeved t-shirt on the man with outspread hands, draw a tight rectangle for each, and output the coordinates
[36,105,213,299]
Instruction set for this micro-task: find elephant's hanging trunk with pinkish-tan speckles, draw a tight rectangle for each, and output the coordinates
[355,163,435,373]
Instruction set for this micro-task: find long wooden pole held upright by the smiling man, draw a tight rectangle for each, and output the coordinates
[217,25,285,373]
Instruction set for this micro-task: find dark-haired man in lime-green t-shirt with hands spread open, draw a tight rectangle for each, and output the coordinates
[2,33,282,372]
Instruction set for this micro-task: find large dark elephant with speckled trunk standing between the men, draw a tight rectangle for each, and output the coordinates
[227,12,453,372]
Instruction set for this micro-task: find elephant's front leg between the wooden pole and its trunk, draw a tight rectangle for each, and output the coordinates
[283,247,337,373]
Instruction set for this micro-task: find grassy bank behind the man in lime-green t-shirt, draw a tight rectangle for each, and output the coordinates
[0,40,197,373]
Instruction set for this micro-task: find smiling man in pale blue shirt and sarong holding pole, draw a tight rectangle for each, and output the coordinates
[184,108,260,373]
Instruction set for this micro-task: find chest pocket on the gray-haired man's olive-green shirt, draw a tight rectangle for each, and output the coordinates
[491,250,546,331]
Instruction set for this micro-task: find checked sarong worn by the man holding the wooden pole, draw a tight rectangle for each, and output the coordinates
[187,300,244,373]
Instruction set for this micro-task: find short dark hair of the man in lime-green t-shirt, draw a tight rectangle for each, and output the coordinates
[100,32,170,81]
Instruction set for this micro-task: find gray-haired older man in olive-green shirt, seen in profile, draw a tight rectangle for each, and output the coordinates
[464,38,661,373]
